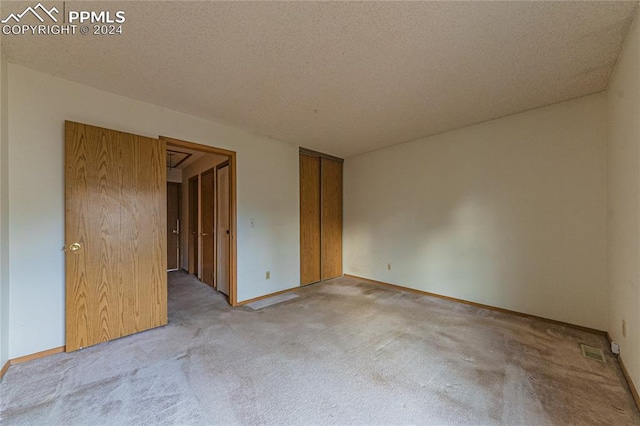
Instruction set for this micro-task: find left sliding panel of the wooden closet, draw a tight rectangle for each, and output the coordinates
[300,154,321,285]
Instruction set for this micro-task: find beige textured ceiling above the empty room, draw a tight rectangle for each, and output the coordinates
[1,1,637,157]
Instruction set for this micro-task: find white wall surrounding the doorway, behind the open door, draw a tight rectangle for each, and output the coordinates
[2,64,300,358]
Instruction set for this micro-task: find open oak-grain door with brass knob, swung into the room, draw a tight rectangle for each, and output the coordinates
[65,121,167,351]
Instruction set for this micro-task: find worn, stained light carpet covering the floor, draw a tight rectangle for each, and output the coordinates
[0,273,640,425]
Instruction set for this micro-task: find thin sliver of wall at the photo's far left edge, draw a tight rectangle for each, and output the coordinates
[0,53,9,368]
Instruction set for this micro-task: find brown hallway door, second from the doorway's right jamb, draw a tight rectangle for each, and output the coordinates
[200,168,216,288]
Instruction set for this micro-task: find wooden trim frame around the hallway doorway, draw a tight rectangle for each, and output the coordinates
[160,136,238,306]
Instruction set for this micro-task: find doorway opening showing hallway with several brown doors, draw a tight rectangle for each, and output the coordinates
[160,136,237,306]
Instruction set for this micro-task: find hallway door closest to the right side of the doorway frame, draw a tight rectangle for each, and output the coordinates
[216,163,231,296]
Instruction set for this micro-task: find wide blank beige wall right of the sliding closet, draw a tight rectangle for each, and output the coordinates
[344,94,607,330]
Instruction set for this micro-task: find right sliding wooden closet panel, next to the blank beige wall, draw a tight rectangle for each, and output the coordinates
[320,158,342,280]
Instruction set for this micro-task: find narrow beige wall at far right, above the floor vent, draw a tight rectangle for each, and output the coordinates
[607,11,640,389]
